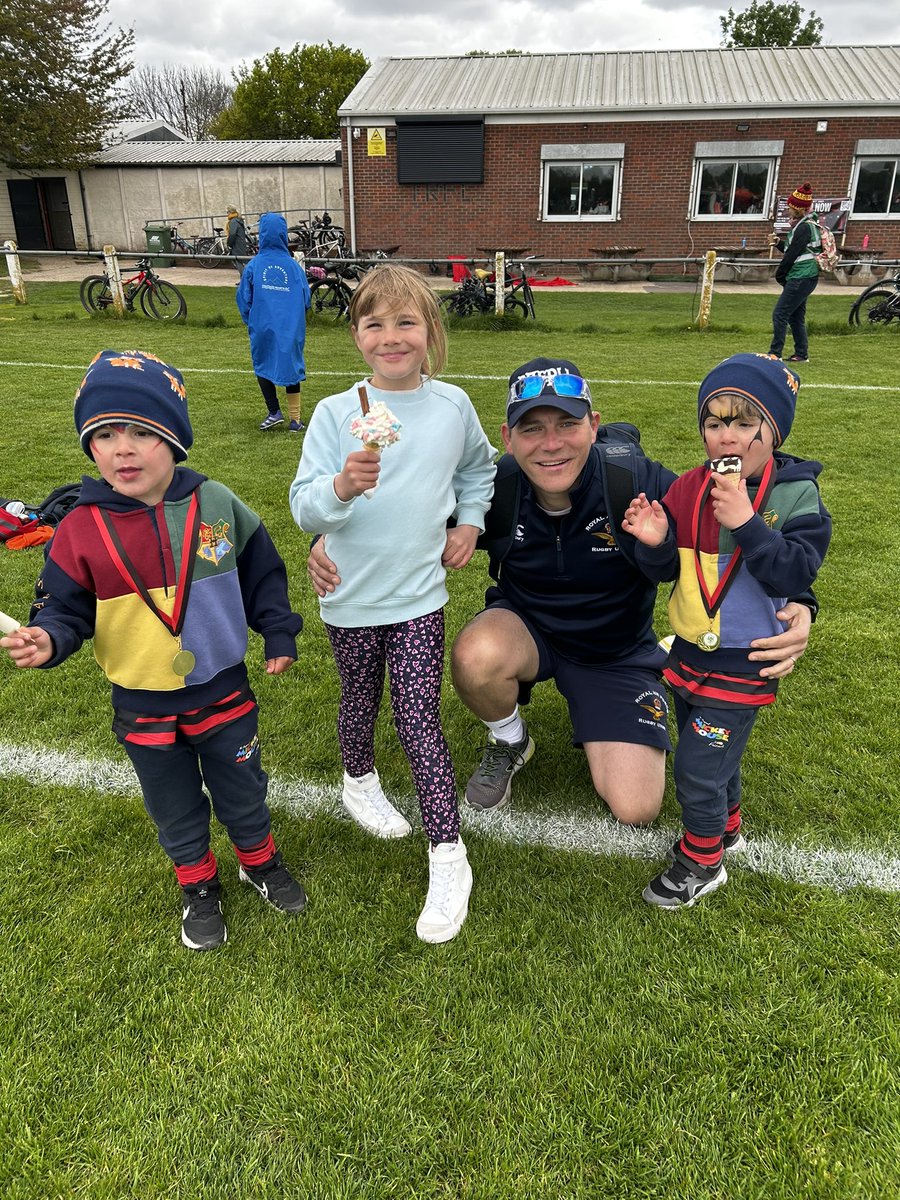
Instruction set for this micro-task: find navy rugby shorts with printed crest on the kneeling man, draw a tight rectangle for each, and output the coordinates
[488,600,672,751]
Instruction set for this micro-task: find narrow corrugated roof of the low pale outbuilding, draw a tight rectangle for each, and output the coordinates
[94,138,341,167]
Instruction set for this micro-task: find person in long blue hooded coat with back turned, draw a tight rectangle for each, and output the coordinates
[235,212,310,433]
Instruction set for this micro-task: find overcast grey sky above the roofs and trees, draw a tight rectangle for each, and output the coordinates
[109,0,900,73]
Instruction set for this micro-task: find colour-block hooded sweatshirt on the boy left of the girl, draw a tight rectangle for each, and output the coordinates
[29,467,302,714]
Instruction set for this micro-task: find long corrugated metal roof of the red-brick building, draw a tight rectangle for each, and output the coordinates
[340,46,900,119]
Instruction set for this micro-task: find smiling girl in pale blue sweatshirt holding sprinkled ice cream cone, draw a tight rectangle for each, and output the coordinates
[290,264,494,942]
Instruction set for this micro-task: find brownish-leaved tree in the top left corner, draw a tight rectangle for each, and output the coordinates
[0,0,134,170]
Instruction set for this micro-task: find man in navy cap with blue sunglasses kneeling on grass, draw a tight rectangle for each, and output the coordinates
[308,359,811,844]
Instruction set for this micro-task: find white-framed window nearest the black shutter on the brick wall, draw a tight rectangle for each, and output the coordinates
[541,143,625,221]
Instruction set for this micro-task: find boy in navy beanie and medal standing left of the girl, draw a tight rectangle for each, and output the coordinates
[0,350,306,950]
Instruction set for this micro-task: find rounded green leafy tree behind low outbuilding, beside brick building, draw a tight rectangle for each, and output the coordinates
[211,42,368,138]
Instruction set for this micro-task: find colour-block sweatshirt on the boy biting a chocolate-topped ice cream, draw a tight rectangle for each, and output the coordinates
[637,450,832,703]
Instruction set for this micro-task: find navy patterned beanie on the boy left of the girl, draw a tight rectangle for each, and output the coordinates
[74,350,193,462]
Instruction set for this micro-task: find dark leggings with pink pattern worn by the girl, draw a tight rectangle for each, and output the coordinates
[325,608,460,846]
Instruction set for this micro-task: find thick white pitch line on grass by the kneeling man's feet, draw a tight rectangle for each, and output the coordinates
[0,742,900,892]
